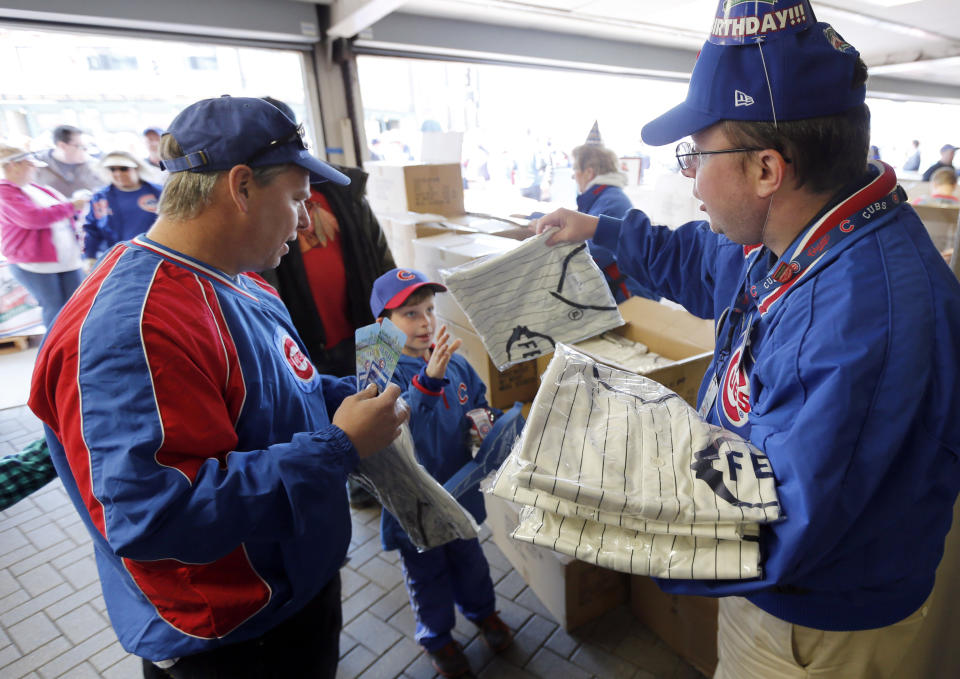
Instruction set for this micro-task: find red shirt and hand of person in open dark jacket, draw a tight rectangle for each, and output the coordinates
[297,190,354,349]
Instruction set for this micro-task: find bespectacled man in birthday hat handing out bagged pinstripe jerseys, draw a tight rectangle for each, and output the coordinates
[537,0,960,679]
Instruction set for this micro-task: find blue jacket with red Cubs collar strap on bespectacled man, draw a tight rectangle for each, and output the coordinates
[595,163,960,630]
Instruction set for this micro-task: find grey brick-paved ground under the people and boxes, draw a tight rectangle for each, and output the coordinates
[0,407,701,679]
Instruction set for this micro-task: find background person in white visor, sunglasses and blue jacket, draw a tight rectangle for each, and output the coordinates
[83,151,162,271]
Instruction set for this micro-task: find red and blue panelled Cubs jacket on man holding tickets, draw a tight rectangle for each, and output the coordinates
[30,236,357,660]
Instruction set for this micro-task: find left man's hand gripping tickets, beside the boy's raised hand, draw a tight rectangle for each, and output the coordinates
[333,384,410,457]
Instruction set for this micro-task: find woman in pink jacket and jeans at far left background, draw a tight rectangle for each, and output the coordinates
[0,144,88,329]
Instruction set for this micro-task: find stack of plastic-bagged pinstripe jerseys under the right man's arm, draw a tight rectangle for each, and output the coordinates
[492,344,781,579]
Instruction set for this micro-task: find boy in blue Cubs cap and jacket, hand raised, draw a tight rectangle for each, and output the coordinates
[370,269,513,677]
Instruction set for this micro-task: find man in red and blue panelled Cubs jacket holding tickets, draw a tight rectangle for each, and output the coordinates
[30,97,404,679]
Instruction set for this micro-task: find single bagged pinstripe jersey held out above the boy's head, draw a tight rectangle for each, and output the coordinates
[440,233,623,370]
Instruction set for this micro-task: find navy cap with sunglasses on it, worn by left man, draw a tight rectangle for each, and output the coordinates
[160,95,350,185]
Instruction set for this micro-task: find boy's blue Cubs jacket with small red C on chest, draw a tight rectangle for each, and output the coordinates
[380,354,499,550]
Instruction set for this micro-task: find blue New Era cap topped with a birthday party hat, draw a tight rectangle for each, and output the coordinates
[640,0,867,146]
